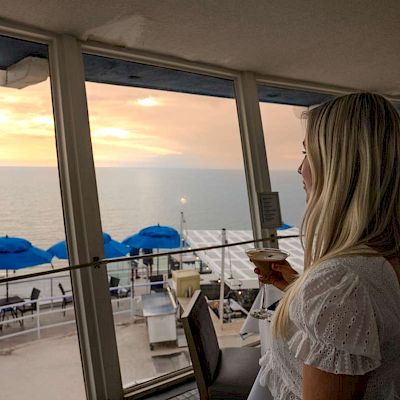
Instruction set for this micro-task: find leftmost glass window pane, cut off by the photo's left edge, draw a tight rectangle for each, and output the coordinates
[0,36,85,400]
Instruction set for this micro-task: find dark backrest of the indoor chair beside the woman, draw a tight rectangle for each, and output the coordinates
[182,290,221,399]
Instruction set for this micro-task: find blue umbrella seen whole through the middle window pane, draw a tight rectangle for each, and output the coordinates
[122,225,181,249]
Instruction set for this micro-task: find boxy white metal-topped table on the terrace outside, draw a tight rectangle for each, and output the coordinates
[142,292,177,350]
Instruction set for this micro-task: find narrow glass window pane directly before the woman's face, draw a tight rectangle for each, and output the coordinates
[258,85,333,226]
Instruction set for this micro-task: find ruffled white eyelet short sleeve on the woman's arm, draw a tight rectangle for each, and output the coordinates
[289,265,381,375]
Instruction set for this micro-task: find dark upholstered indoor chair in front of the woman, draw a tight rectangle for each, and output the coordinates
[182,290,260,400]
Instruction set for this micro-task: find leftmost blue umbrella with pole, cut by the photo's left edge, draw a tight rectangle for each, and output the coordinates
[0,236,53,299]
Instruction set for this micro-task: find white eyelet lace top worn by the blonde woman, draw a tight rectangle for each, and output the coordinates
[260,256,400,400]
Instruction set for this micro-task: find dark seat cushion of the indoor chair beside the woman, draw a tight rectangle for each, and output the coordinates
[208,347,260,400]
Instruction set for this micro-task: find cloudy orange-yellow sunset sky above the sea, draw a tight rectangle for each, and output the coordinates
[0,80,304,170]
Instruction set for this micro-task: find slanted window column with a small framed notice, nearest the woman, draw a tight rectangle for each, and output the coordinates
[235,72,278,247]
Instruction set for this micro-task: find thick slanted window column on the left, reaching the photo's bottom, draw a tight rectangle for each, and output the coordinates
[50,36,123,400]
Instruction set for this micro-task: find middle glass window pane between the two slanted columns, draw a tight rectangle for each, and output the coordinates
[84,55,258,386]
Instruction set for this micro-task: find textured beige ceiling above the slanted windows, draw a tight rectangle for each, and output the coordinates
[0,0,400,97]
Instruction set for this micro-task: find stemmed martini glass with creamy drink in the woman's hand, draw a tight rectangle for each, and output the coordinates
[246,248,289,319]
